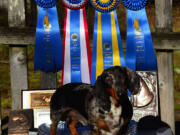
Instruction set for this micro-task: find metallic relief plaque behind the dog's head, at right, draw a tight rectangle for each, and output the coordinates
[131,71,159,121]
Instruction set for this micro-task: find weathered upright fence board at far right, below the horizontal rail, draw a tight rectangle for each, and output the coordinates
[157,51,175,133]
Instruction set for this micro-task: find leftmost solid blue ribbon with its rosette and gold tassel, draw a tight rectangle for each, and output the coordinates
[34,0,62,72]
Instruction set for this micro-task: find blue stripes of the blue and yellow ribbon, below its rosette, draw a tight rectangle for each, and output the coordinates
[91,10,125,84]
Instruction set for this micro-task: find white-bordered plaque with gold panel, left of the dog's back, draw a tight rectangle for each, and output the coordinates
[22,89,55,109]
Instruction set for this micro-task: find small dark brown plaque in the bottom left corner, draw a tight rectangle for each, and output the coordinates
[8,109,33,135]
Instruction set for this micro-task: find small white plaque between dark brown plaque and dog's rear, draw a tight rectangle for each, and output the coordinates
[34,109,51,128]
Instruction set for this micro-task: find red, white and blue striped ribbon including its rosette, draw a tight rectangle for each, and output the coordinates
[62,0,91,85]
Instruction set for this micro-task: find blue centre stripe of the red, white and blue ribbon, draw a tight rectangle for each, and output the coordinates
[70,10,81,82]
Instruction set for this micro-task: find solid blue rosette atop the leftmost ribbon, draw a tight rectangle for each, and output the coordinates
[35,0,57,8]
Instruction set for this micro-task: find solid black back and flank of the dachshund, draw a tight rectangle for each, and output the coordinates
[50,83,92,118]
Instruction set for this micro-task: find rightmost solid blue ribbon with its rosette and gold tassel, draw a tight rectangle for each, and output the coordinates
[123,0,157,71]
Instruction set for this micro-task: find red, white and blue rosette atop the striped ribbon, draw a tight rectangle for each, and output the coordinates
[62,0,88,9]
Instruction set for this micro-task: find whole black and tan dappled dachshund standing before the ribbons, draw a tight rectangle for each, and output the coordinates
[50,66,140,135]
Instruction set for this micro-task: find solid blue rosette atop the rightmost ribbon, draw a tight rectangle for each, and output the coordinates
[122,0,147,11]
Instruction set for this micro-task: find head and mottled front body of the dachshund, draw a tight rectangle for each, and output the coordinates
[86,66,140,135]
